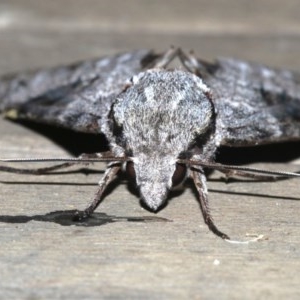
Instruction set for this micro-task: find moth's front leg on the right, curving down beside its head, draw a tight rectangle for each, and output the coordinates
[191,170,230,240]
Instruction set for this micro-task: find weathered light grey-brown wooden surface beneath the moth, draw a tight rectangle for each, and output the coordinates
[0,0,300,299]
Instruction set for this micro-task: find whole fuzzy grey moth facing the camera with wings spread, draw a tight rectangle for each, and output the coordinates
[0,48,300,239]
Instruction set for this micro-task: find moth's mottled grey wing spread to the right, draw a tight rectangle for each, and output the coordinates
[199,59,300,146]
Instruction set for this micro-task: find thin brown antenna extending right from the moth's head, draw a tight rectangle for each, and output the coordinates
[177,159,300,177]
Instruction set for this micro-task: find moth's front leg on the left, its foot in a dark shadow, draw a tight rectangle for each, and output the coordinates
[73,165,121,221]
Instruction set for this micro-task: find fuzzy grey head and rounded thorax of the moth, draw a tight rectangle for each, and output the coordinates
[112,69,215,210]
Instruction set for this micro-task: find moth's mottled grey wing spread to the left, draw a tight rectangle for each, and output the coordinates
[0,50,157,132]
